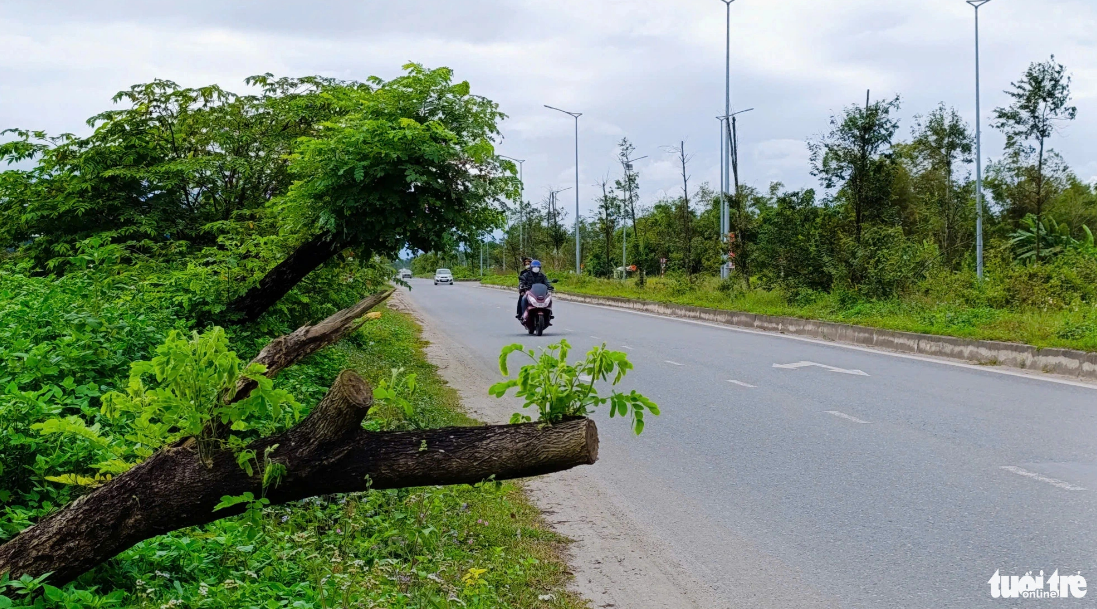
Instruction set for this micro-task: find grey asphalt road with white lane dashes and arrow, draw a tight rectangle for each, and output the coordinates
[410,280,1097,609]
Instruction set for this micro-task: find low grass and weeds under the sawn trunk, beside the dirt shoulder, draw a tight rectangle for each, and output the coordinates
[85,309,588,609]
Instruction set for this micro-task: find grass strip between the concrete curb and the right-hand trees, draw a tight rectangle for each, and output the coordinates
[482,274,1097,351]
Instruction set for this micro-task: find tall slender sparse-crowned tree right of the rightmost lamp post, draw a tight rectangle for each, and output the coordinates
[994,55,1077,259]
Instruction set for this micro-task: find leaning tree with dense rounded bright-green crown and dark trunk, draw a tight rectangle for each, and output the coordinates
[229,64,517,320]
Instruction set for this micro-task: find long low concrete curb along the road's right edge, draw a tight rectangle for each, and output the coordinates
[480,283,1097,381]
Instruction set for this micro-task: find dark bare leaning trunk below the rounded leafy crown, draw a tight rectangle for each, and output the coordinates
[226,233,346,324]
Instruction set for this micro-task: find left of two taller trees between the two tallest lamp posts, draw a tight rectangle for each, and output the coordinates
[808,97,900,245]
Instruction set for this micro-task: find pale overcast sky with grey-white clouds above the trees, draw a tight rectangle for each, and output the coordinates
[0,0,1097,221]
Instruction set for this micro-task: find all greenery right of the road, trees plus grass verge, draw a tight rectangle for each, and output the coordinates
[443,57,1097,350]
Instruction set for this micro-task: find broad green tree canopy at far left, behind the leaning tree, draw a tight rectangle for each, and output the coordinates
[0,75,351,264]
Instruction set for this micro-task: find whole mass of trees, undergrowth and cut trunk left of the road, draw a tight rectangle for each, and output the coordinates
[0,64,657,609]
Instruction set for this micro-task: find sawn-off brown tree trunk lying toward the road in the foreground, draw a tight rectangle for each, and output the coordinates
[0,371,598,585]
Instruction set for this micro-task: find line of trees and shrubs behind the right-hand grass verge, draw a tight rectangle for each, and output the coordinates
[425,57,1097,297]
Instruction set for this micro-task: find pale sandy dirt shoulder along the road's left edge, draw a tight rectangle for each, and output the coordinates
[389,290,727,609]
